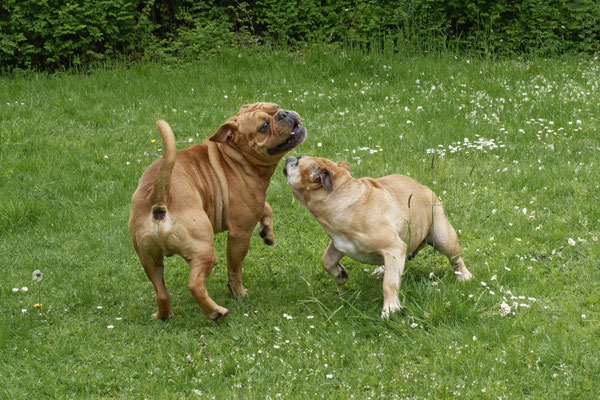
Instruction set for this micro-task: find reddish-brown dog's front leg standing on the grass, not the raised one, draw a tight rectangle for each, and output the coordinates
[227,229,252,297]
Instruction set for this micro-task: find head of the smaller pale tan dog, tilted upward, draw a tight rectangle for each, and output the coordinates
[283,156,350,205]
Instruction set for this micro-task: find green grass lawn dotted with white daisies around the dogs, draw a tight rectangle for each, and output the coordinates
[0,49,600,399]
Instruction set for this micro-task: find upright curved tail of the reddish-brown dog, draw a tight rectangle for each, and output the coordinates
[152,119,176,221]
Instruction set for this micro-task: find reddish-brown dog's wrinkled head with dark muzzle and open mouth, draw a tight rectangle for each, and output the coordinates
[210,103,306,165]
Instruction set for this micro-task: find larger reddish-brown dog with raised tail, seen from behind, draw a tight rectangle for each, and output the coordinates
[129,103,306,319]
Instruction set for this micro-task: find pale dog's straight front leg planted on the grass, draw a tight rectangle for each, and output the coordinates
[381,242,406,319]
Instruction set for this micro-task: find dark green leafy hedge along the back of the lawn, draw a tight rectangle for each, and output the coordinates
[0,0,600,70]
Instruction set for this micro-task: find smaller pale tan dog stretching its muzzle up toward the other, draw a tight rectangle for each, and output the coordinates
[283,157,471,318]
